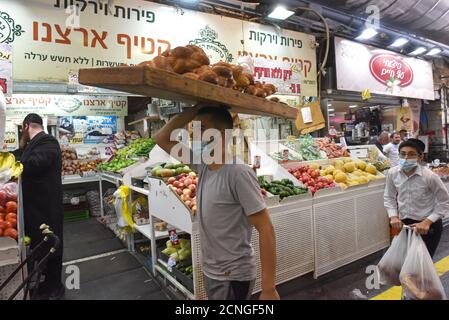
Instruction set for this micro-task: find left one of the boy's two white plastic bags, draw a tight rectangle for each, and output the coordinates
[377,228,408,286]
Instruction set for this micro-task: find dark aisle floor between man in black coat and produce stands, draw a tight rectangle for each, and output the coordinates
[63,219,167,300]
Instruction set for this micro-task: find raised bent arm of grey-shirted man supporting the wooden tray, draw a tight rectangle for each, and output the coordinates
[154,106,200,164]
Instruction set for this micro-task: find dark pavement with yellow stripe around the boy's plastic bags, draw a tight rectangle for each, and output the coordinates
[272,227,449,300]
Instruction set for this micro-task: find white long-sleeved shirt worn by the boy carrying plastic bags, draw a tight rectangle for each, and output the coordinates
[384,165,449,222]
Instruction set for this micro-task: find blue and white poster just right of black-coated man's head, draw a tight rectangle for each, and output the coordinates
[58,116,117,145]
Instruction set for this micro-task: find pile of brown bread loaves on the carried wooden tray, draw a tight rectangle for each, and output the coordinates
[139,45,278,97]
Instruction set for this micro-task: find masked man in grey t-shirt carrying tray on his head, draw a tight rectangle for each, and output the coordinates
[155,106,279,300]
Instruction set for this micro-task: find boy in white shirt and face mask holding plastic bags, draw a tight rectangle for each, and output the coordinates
[384,139,449,256]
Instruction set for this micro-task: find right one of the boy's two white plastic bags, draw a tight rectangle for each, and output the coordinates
[399,231,446,300]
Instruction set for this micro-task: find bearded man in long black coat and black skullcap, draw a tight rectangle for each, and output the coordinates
[14,113,64,299]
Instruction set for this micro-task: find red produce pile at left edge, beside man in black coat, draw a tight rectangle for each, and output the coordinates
[0,182,18,240]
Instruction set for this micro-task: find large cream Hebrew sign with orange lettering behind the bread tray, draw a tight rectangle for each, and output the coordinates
[0,0,317,96]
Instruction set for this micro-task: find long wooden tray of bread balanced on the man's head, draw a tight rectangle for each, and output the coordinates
[79,66,298,119]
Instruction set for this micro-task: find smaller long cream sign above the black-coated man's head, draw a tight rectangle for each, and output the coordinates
[6,94,128,116]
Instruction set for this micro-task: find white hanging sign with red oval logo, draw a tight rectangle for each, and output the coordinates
[335,37,435,100]
